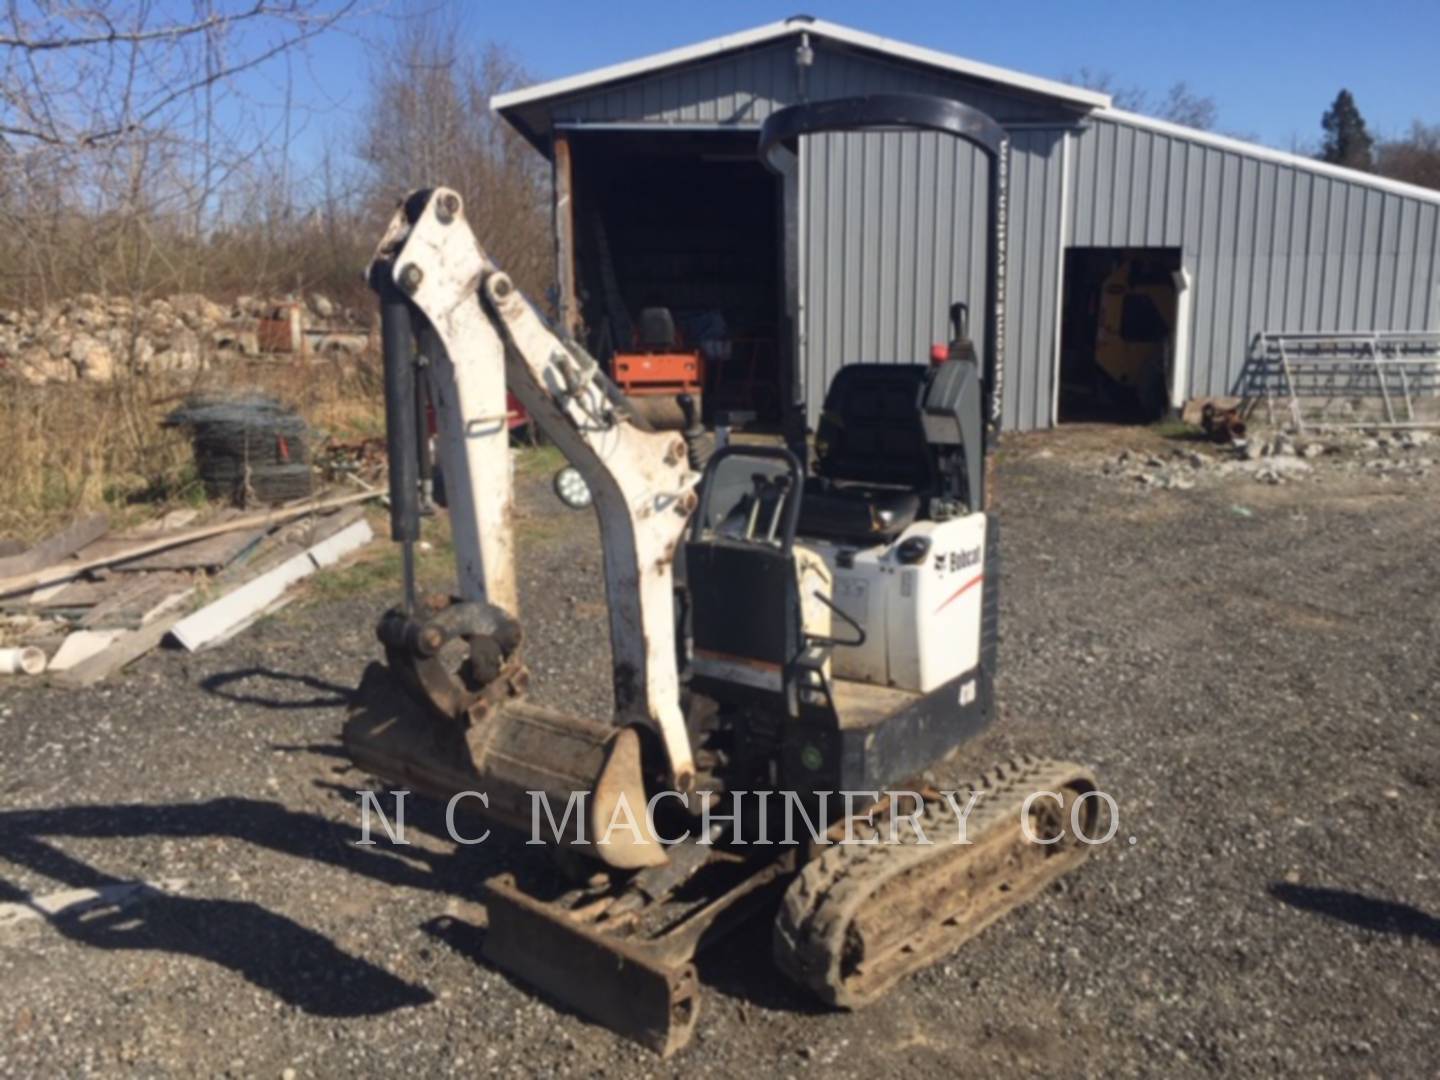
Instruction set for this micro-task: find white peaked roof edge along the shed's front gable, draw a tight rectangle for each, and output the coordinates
[490,16,1110,111]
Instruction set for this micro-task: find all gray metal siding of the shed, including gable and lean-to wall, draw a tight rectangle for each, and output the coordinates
[536,39,1440,429]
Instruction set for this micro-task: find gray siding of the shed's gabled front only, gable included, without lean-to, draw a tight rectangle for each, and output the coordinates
[552,34,1076,428]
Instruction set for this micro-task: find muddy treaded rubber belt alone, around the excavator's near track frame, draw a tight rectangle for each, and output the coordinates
[775,756,1094,1008]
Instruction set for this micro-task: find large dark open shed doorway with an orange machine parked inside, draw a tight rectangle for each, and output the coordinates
[570,131,782,425]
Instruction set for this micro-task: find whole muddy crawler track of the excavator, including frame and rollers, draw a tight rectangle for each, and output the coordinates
[775,759,1099,1008]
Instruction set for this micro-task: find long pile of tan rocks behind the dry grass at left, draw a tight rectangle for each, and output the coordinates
[0,292,357,384]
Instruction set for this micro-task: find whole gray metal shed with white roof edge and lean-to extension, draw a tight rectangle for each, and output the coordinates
[492,17,1440,429]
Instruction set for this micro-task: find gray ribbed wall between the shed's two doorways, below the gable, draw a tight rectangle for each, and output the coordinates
[802,131,1064,428]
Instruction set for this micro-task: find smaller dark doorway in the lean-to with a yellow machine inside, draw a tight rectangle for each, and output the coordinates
[1060,248,1181,423]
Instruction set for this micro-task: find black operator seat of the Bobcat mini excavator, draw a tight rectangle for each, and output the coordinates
[796,364,936,544]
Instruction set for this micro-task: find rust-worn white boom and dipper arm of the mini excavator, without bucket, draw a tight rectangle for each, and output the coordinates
[357,187,698,792]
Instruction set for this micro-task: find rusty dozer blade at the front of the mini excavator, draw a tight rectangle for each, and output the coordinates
[484,876,700,1057]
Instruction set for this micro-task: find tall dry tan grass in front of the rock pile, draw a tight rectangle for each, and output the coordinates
[0,352,384,540]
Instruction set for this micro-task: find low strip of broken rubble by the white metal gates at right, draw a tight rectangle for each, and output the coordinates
[1100,429,1440,491]
